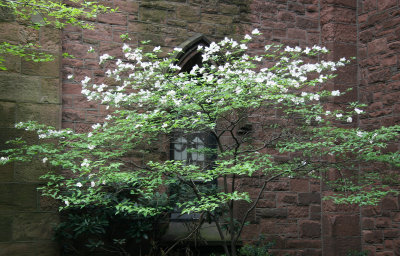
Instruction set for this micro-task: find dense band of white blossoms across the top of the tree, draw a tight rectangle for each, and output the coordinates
[77,32,358,124]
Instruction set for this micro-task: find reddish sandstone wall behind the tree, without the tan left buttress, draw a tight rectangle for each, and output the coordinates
[62,0,400,256]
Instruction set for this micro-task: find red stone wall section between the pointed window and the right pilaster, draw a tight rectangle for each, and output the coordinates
[243,0,323,256]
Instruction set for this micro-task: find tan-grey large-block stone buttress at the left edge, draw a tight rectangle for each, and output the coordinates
[0,4,61,256]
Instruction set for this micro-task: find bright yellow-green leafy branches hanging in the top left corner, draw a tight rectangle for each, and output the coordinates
[0,0,116,70]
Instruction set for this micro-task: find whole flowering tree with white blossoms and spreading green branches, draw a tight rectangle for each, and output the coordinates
[1,30,400,255]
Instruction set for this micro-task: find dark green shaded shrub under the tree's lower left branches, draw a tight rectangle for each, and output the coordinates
[55,198,167,255]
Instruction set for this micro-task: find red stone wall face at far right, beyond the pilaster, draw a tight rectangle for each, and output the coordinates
[358,0,400,256]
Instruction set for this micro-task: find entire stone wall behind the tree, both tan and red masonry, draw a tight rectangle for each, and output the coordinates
[0,0,400,256]
